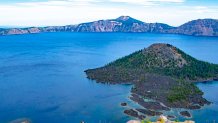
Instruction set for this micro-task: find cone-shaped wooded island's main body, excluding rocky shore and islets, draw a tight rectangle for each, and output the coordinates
[86,44,218,106]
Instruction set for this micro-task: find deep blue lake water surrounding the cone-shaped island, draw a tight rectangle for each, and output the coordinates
[0,33,218,123]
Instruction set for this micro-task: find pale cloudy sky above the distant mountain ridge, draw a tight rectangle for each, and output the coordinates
[0,0,218,27]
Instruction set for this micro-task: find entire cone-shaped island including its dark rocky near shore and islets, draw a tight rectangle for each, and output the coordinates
[85,43,218,119]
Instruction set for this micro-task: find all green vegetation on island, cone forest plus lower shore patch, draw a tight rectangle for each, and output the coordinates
[104,45,218,102]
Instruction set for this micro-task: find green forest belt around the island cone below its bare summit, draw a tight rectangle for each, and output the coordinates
[106,46,218,80]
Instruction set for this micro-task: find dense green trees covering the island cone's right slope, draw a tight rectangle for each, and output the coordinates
[163,49,218,80]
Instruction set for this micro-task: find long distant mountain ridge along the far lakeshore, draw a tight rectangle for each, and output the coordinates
[0,16,218,36]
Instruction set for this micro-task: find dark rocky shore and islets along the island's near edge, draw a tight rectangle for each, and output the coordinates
[87,71,211,120]
